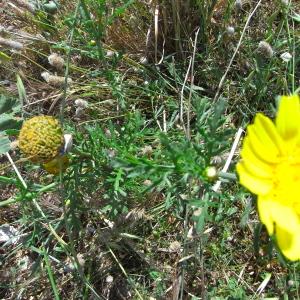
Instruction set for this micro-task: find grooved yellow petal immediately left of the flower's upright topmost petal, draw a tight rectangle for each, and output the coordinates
[251,113,284,154]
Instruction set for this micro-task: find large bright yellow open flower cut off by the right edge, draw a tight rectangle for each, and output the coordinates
[236,95,300,261]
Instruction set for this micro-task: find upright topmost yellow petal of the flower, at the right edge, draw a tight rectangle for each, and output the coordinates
[276,95,300,141]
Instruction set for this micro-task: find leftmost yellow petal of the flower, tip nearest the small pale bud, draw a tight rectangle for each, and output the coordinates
[236,162,273,195]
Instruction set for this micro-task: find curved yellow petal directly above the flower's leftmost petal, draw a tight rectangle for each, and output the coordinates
[241,137,273,179]
